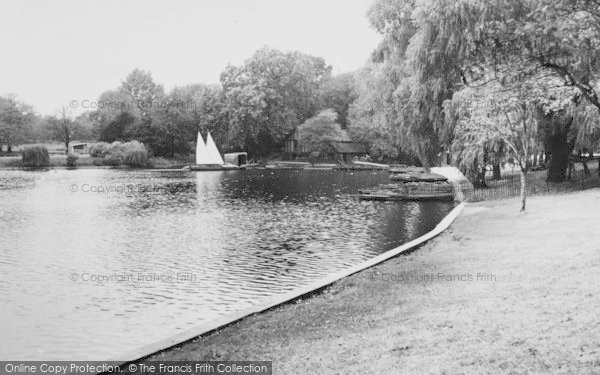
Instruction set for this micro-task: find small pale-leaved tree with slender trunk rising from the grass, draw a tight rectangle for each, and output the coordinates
[445,78,573,211]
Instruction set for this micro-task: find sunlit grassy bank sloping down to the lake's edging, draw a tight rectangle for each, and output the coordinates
[138,190,600,374]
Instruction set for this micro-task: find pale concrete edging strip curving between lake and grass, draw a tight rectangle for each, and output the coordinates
[109,202,466,364]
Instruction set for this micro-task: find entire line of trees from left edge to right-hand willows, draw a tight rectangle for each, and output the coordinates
[0,0,600,191]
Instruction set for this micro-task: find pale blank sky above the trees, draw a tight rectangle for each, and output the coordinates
[0,0,380,115]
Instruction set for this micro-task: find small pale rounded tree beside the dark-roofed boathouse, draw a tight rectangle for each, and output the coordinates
[298,109,344,154]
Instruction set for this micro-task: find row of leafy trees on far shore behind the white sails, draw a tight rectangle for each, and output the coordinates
[0,47,368,157]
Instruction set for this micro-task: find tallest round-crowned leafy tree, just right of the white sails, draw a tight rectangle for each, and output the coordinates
[221,47,331,155]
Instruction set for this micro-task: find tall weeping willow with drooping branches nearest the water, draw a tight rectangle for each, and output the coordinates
[369,0,481,168]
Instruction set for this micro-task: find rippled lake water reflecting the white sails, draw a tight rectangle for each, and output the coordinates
[0,169,454,361]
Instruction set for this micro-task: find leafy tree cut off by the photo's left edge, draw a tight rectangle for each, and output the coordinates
[0,95,36,152]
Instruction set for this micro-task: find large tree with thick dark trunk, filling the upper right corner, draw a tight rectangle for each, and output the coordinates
[463,0,600,181]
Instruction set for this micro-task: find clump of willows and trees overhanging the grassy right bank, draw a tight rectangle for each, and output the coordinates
[351,0,600,189]
